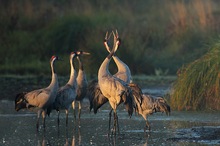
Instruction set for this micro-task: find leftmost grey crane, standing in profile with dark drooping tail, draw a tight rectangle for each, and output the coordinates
[15,56,59,130]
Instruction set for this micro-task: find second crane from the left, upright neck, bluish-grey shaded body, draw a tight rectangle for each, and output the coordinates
[47,52,77,126]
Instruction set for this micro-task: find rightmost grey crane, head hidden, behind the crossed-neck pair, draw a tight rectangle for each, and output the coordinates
[129,83,170,131]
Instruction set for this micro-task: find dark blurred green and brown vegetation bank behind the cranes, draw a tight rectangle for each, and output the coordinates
[0,0,220,76]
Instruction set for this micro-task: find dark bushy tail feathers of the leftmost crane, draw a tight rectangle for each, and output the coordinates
[15,92,27,111]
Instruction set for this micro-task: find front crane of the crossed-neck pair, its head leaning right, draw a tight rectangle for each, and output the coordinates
[98,32,133,134]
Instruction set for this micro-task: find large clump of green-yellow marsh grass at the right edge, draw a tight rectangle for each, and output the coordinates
[171,41,220,110]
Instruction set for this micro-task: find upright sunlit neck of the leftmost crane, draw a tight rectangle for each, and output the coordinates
[47,61,59,91]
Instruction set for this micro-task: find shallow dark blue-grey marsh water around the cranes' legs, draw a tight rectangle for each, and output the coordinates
[0,77,220,146]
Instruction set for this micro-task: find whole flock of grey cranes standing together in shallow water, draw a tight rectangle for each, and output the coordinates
[15,30,170,134]
